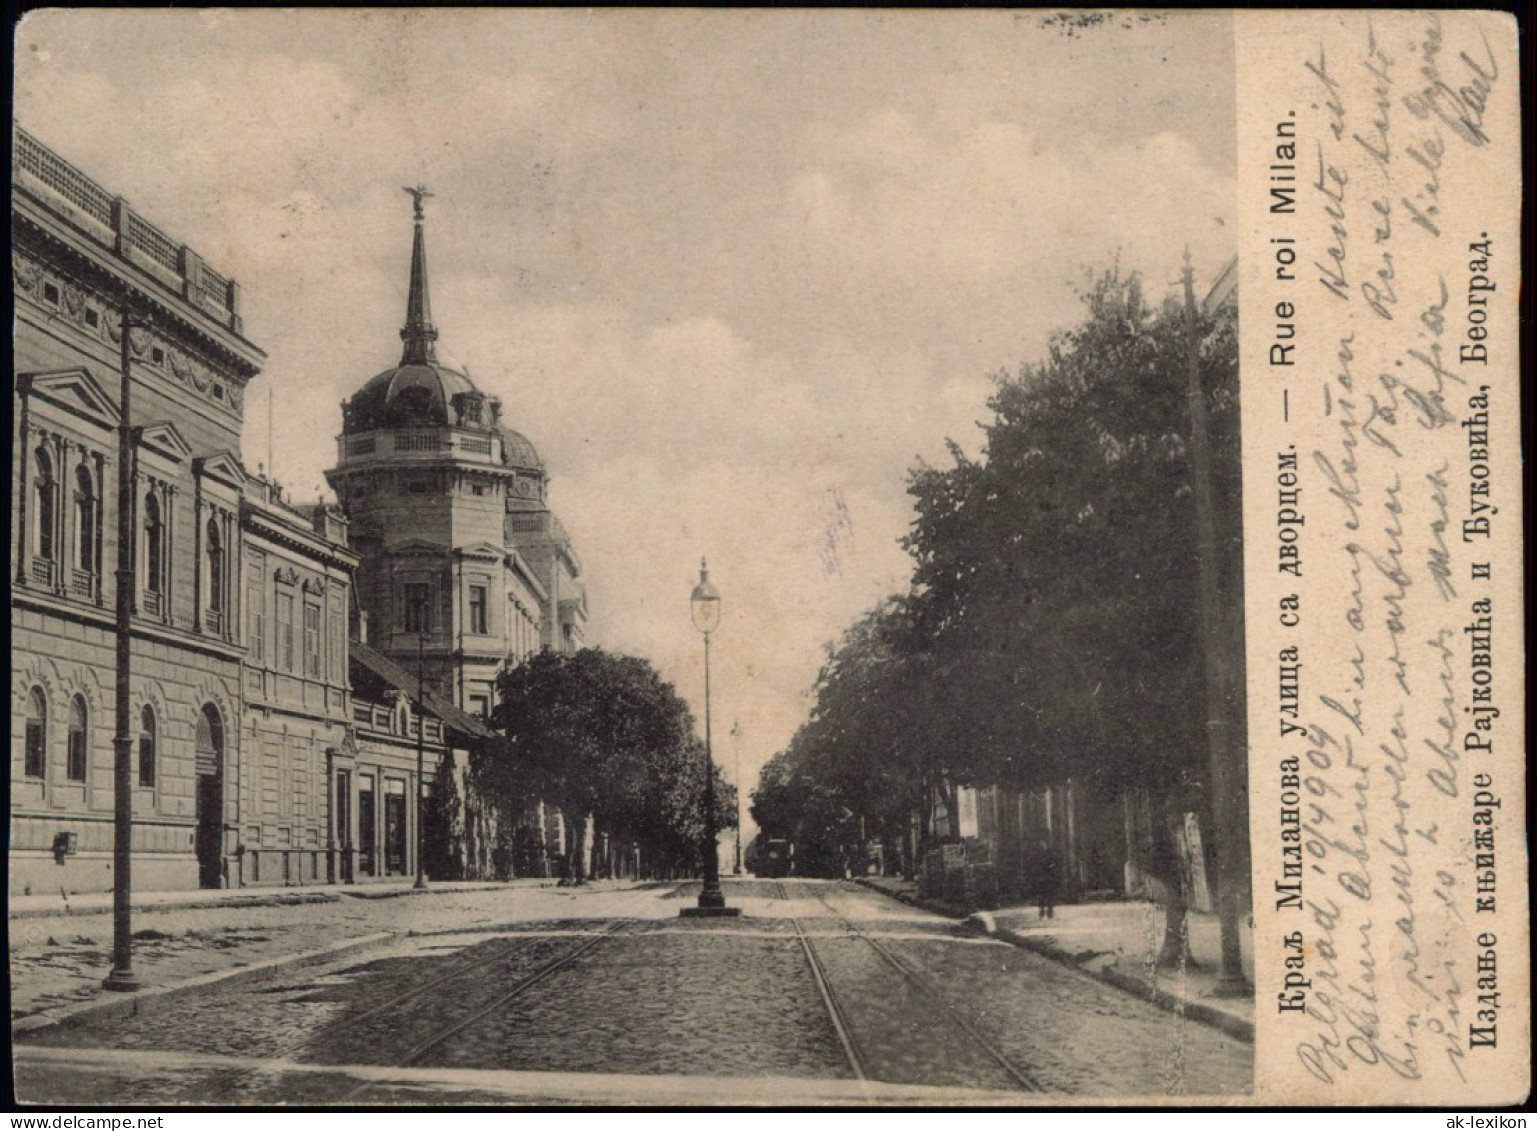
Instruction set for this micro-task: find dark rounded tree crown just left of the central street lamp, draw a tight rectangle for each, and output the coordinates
[480,648,735,881]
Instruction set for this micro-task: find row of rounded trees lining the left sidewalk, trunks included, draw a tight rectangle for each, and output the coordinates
[424,648,736,882]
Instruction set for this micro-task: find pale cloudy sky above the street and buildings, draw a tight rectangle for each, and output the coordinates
[15,9,1234,829]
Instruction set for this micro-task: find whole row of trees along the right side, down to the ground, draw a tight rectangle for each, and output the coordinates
[752,270,1248,957]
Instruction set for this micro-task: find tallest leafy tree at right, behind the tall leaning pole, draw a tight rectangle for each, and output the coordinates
[907,272,1242,965]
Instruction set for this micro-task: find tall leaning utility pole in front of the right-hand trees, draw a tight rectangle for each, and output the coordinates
[1185,256,1253,997]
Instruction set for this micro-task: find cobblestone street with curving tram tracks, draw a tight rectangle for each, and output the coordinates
[12,881,1253,1103]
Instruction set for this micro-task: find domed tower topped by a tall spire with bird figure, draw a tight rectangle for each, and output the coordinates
[326,187,586,713]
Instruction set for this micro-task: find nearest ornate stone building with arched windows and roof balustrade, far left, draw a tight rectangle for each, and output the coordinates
[9,128,263,891]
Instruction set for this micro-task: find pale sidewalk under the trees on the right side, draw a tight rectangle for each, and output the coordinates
[859,876,1254,1042]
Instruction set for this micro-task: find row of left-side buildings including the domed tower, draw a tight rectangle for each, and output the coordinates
[9,126,593,894]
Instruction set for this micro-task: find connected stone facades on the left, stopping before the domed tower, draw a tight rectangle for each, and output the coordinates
[9,128,464,893]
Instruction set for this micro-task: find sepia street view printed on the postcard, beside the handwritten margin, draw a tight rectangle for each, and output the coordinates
[8,9,1475,1109]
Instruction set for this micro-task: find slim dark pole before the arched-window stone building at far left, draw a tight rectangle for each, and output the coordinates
[98,308,146,991]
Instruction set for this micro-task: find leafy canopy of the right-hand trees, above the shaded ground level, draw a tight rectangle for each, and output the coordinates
[753,270,1242,956]
